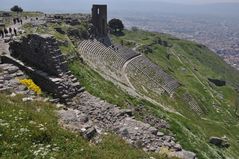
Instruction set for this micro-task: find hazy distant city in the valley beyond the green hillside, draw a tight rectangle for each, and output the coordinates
[115,14,239,70]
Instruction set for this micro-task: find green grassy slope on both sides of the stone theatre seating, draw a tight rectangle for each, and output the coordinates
[20,21,239,159]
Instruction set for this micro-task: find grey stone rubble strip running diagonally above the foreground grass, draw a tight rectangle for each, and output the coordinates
[59,92,196,159]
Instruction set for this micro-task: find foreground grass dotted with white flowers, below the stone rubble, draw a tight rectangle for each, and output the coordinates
[0,94,173,159]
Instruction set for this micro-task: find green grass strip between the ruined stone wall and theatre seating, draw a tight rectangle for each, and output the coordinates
[70,61,140,108]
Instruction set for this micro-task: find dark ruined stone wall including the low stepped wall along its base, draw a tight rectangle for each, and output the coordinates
[5,34,84,105]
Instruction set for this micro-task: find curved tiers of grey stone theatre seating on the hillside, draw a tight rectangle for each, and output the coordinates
[79,39,180,95]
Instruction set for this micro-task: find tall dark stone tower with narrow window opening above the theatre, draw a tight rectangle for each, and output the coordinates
[92,4,107,37]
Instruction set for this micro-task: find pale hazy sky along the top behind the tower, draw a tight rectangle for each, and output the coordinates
[0,0,239,12]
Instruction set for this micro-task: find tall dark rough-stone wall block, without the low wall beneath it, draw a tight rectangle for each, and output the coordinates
[10,34,68,76]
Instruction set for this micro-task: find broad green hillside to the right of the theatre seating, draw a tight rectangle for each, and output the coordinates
[109,31,239,158]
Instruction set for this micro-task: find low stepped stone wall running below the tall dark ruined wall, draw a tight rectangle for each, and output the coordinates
[1,56,84,105]
